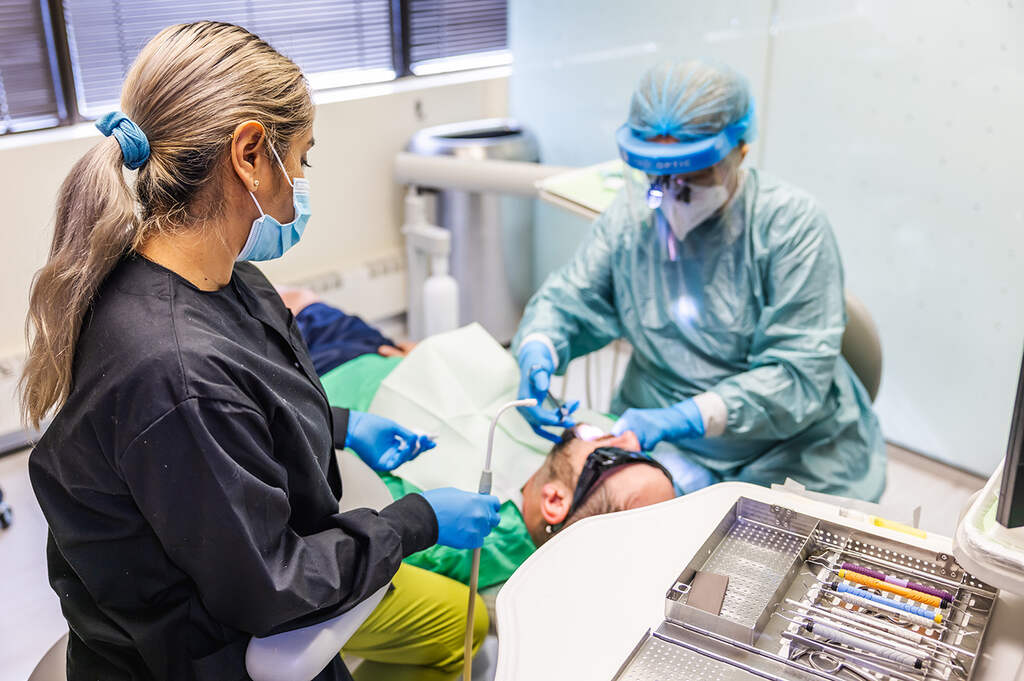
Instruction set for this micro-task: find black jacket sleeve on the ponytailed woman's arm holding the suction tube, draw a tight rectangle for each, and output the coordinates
[119,397,437,636]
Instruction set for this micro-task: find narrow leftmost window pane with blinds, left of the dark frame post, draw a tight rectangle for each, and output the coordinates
[0,0,65,134]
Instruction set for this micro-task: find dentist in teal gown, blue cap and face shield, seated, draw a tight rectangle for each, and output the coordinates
[513,61,886,500]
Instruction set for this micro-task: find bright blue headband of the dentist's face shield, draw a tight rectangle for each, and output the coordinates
[615,103,757,175]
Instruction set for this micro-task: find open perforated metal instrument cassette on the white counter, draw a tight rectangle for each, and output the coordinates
[614,498,998,681]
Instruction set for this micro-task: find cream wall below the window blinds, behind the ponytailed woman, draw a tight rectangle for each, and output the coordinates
[0,70,508,355]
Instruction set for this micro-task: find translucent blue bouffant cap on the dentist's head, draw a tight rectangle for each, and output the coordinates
[629,60,753,142]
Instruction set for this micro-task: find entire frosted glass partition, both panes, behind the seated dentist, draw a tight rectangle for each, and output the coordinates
[510,0,1024,475]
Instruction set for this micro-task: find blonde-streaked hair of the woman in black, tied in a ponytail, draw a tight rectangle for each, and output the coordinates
[20,22,312,427]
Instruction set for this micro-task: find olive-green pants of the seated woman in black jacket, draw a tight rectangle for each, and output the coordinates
[342,563,488,681]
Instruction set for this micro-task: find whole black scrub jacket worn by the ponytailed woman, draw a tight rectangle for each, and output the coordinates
[29,255,437,681]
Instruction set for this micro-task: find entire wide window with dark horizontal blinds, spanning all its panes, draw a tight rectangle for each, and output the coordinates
[0,0,509,134]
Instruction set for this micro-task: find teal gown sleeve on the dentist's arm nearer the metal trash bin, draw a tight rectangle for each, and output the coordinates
[512,205,622,370]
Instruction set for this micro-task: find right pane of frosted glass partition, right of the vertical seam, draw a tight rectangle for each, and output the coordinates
[763,0,1024,474]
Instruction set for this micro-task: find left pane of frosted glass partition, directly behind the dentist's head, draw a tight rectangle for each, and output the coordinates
[509,0,770,283]
